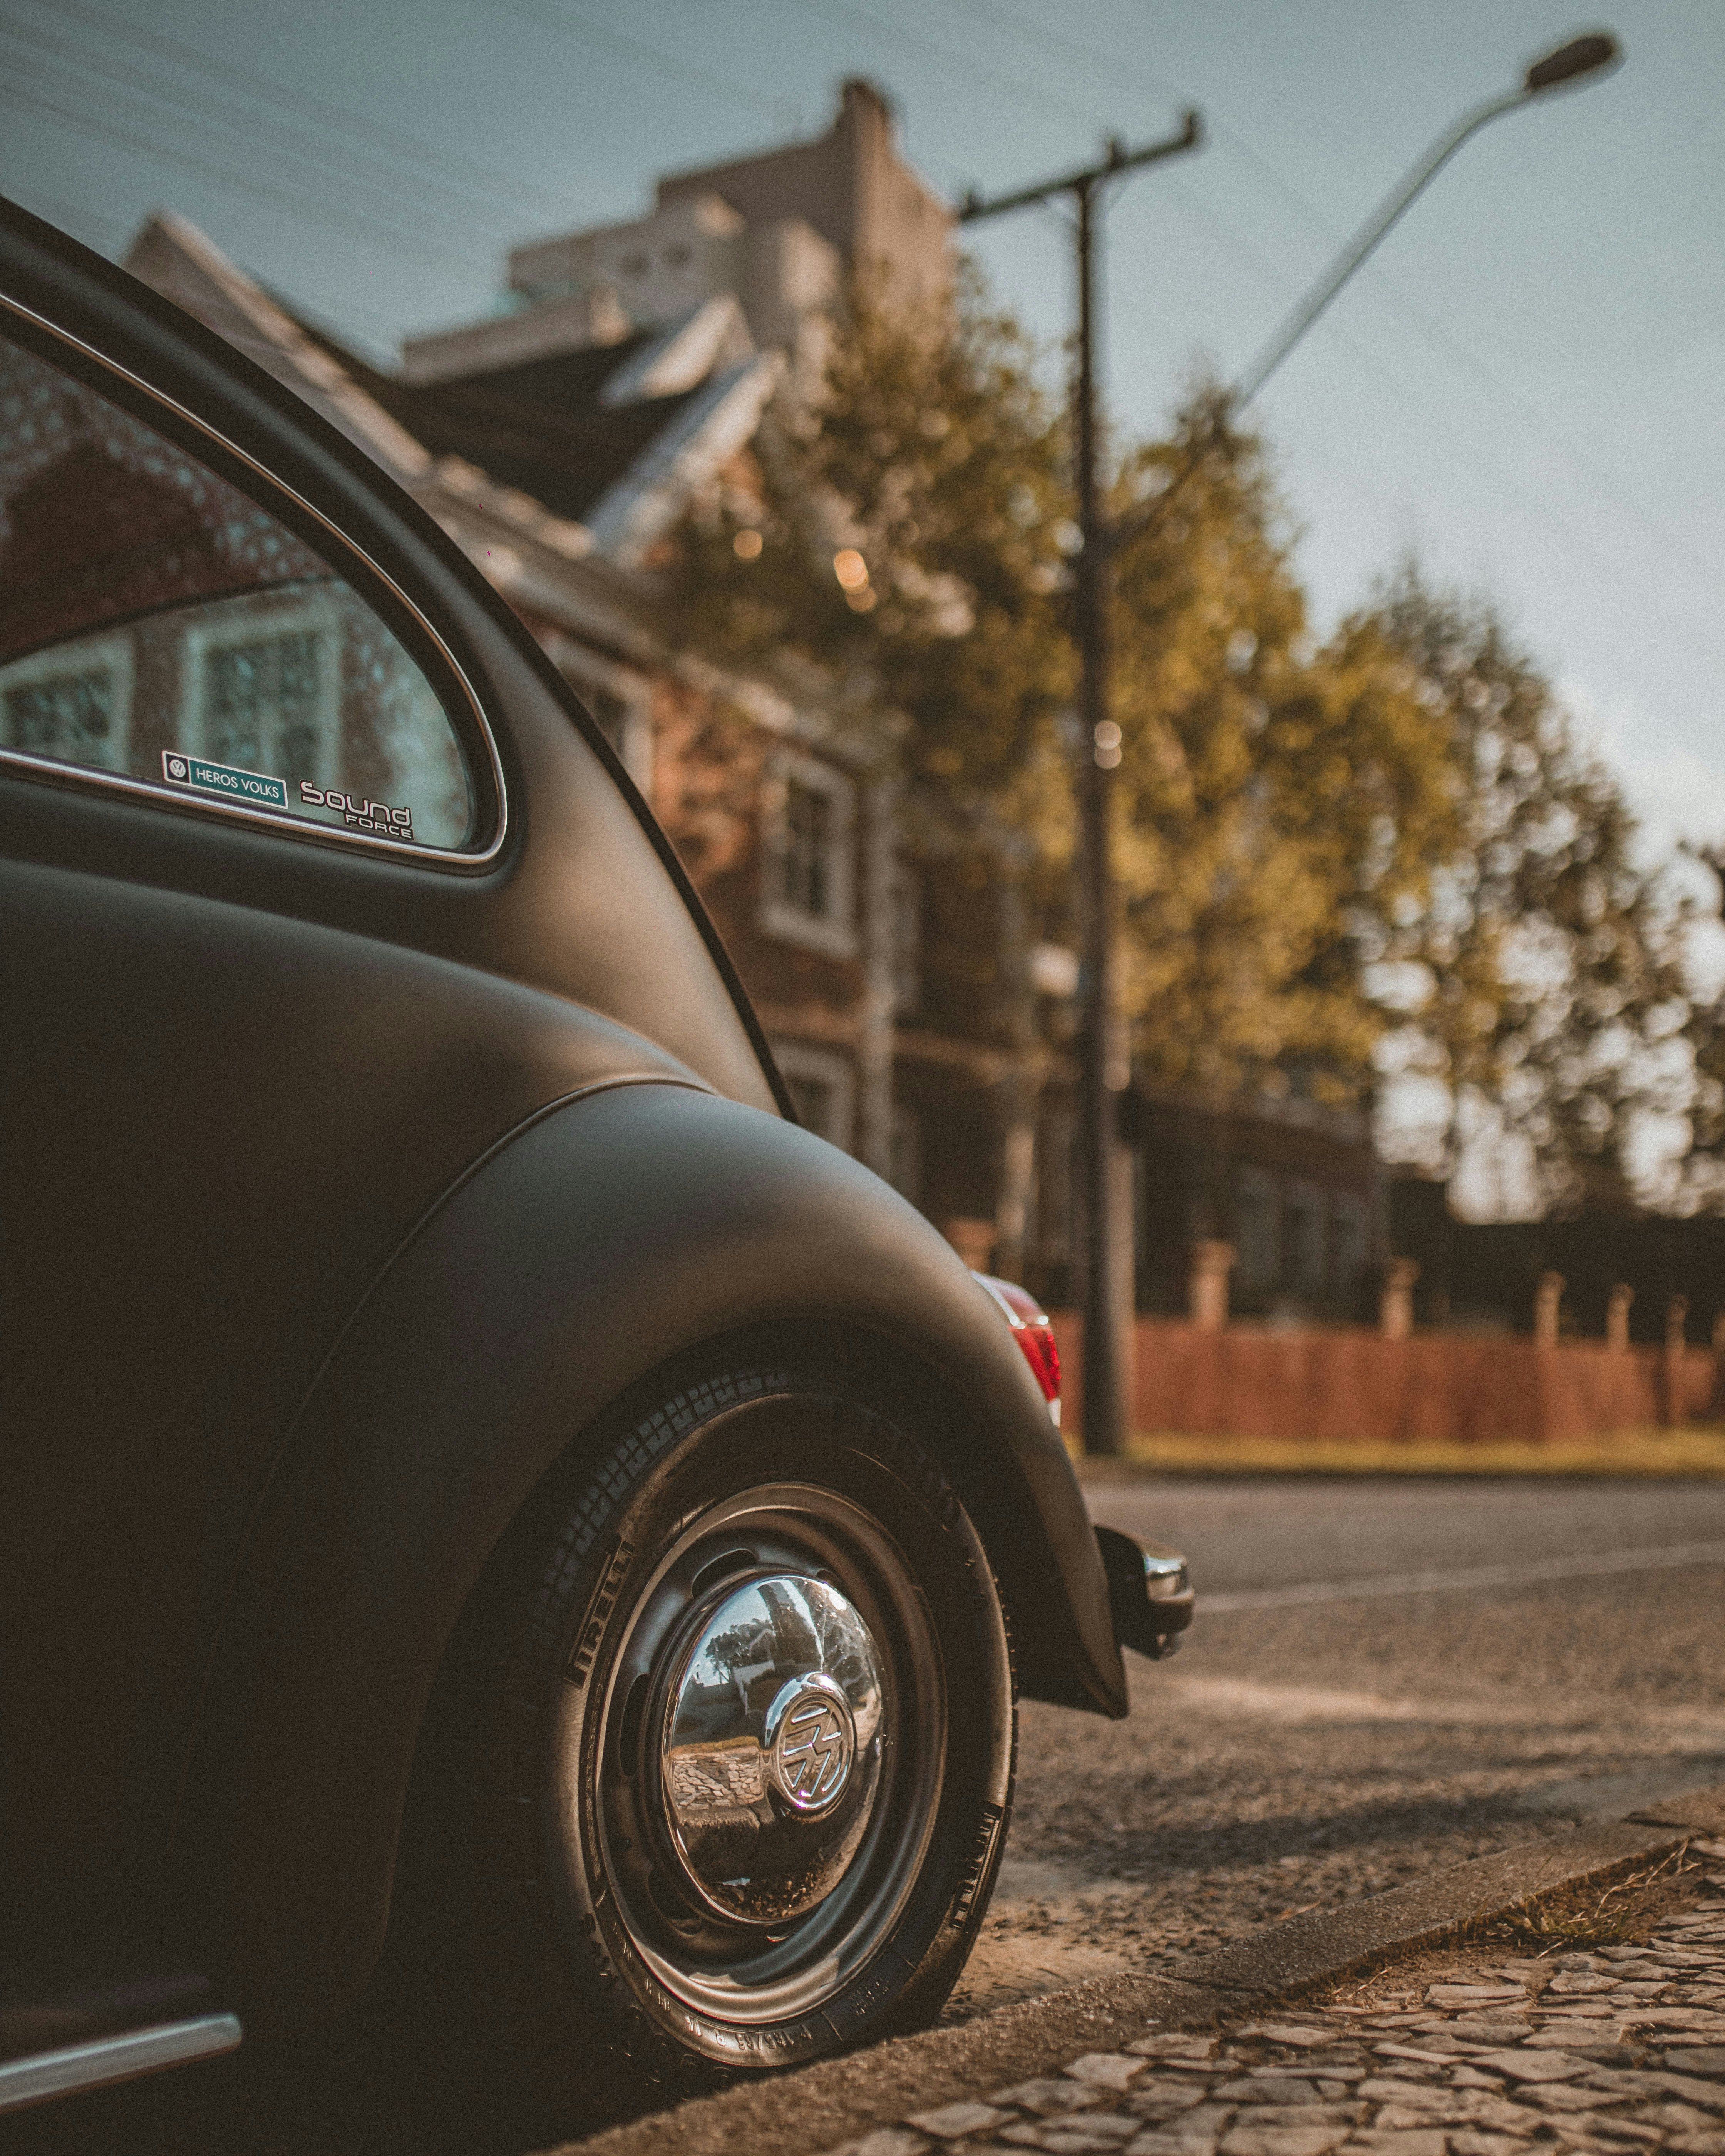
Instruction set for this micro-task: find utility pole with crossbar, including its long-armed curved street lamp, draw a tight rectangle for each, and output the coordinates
[960,30,1624,1453]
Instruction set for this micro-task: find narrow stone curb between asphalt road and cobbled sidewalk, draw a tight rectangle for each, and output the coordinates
[548,1785,1725,2156]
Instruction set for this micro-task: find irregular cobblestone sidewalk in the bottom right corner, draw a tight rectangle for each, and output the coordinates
[832,1871,1725,2156]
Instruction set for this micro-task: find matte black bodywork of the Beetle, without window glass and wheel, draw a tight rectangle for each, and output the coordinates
[0,207,1125,2052]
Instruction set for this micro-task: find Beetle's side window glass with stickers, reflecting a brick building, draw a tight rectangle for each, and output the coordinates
[0,323,474,847]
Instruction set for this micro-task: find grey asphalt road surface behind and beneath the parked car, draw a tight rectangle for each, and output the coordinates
[7,1479,1725,2156]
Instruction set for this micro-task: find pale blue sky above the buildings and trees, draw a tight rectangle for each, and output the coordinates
[0,0,1725,888]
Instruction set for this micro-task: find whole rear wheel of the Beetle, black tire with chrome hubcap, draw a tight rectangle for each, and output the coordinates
[407,1363,1016,2106]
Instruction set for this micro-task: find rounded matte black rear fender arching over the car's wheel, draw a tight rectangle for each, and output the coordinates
[183,1082,1125,2031]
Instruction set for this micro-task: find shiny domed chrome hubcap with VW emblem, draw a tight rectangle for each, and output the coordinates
[649,1572,882,1927]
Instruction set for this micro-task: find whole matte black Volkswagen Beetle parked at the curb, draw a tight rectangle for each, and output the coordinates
[0,207,1192,2106]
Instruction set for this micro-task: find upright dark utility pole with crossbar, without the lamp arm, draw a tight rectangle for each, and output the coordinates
[957,110,1203,1453]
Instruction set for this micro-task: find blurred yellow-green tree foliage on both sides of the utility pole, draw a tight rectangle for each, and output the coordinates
[675,278,1684,1182]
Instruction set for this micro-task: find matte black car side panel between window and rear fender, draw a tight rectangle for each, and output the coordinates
[0,836,698,1947]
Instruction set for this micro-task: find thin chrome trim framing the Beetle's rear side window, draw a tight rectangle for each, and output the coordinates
[0,293,509,875]
